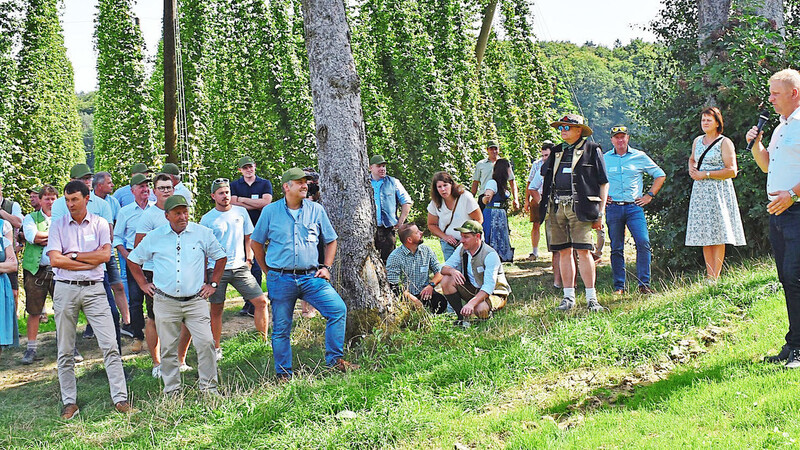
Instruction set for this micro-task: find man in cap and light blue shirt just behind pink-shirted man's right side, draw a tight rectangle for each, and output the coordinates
[112,173,155,354]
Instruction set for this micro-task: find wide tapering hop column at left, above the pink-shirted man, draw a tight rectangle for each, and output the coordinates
[9,0,85,199]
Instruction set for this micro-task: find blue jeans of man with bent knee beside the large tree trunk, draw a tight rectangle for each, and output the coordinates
[267,270,347,375]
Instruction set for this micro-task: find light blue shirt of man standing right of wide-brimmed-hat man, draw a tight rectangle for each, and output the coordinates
[603,146,666,202]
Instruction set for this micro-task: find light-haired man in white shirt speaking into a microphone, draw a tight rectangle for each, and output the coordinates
[747,69,800,369]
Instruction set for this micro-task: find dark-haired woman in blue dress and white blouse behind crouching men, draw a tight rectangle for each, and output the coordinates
[481,158,514,262]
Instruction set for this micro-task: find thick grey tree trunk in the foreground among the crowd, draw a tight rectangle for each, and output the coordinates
[303,0,395,336]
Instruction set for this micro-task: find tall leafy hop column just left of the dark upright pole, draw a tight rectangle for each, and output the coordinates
[94,0,159,185]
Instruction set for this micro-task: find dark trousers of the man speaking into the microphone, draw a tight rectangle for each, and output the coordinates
[769,204,800,348]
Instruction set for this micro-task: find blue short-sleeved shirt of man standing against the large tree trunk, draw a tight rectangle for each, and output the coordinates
[250,199,339,269]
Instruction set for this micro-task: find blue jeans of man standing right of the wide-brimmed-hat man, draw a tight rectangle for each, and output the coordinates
[606,203,652,290]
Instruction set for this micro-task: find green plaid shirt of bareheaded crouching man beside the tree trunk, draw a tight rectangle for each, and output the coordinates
[386,244,442,296]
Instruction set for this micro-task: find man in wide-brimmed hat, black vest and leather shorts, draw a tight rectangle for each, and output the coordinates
[539,114,608,312]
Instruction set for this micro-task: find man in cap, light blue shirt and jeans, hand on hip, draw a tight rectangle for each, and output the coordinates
[603,125,667,294]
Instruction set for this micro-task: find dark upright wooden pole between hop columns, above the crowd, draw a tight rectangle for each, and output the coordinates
[164,0,180,164]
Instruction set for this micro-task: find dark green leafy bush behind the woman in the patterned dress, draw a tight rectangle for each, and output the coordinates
[640,0,800,270]
